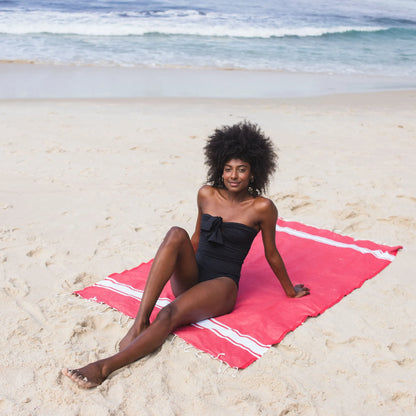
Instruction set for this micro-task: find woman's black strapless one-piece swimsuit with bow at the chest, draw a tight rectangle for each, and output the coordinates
[196,214,258,286]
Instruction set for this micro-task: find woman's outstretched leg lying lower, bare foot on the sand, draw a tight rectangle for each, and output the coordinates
[63,277,237,388]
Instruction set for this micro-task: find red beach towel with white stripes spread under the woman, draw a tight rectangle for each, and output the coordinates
[75,219,402,368]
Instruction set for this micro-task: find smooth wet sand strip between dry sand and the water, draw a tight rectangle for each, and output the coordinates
[0,62,416,99]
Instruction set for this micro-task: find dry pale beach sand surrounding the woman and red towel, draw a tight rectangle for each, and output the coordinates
[0,90,416,416]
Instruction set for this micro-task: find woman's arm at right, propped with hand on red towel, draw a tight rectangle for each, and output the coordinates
[258,198,309,298]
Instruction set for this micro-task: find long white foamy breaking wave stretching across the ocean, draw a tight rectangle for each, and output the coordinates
[0,10,396,38]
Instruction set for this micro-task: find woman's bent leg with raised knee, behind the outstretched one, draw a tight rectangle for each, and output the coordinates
[119,227,198,351]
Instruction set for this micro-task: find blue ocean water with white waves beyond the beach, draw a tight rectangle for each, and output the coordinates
[0,0,416,78]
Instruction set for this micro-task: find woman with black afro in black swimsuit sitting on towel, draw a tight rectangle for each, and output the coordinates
[63,122,309,388]
